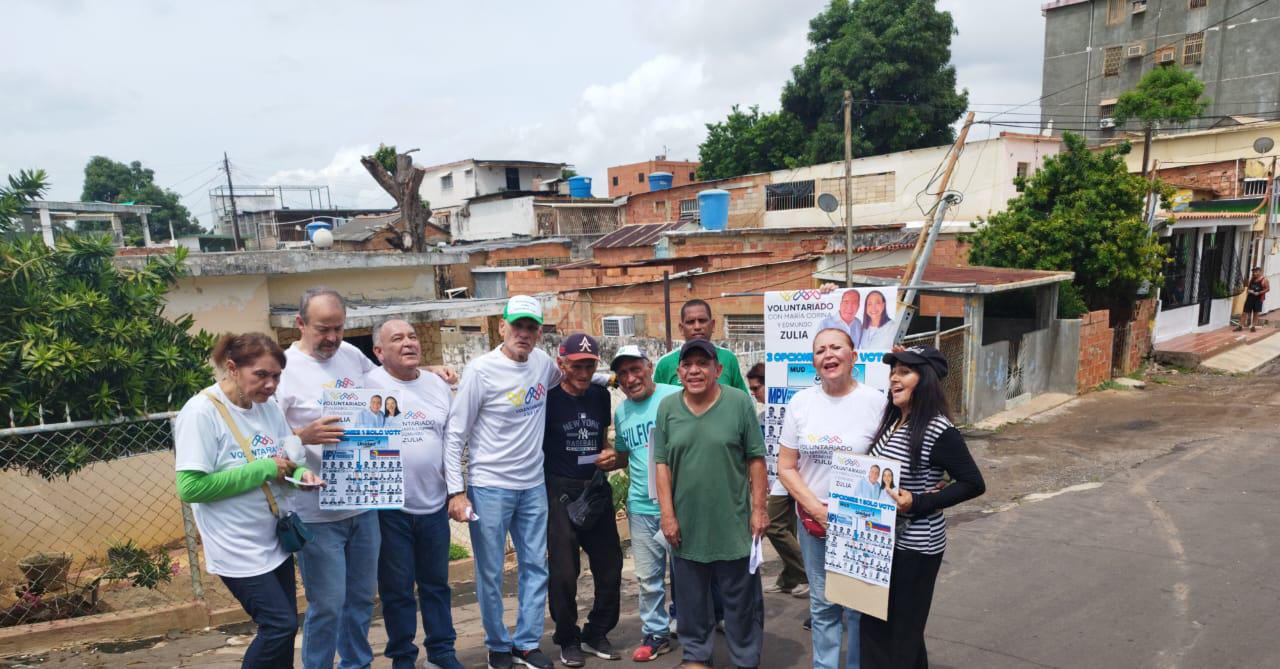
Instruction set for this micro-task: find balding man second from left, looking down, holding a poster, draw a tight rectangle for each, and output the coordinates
[275,288,447,669]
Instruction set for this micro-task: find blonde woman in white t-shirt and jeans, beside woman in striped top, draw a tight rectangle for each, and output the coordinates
[778,327,887,669]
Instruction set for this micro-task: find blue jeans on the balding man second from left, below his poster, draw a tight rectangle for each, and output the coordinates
[301,512,380,669]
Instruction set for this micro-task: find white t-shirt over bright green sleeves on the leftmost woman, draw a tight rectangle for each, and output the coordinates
[173,384,293,578]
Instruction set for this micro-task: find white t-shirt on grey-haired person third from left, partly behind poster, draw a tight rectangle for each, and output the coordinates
[365,367,453,514]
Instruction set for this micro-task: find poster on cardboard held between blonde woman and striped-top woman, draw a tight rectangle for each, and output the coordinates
[826,452,901,620]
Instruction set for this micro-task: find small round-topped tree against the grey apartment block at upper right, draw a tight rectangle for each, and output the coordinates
[1111,64,1210,177]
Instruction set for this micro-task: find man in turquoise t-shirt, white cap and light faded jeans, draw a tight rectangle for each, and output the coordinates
[609,345,680,663]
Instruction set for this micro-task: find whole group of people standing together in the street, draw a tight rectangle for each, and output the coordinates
[175,288,983,669]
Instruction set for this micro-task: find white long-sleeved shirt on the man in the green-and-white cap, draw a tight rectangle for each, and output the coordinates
[444,347,561,492]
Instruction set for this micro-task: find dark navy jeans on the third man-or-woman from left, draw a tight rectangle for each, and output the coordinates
[378,508,457,669]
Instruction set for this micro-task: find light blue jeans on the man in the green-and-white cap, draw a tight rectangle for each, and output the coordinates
[467,485,548,652]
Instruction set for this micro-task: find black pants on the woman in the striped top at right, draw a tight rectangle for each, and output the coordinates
[860,550,942,669]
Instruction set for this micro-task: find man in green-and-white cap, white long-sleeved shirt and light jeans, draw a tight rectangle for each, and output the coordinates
[444,295,561,669]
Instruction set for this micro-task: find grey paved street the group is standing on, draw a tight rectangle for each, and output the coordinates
[10,365,1280,669]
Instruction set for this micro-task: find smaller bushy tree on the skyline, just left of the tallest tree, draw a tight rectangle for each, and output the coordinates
[698,105,805,180]
